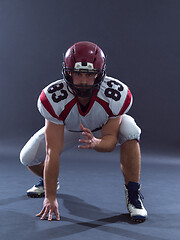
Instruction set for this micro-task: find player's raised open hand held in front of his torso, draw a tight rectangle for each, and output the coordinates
[78,124,97,149]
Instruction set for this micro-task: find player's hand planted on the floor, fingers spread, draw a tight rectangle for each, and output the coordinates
[36,198,60,221]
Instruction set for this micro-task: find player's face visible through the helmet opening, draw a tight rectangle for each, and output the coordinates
[72,72,97,86]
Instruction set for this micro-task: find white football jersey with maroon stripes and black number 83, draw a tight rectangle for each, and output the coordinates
[38,76,132,132]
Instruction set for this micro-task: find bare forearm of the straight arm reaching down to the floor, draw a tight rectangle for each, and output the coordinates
[44,153,59,199]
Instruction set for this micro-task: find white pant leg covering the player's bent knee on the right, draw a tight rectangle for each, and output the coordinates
[119,114,141,144]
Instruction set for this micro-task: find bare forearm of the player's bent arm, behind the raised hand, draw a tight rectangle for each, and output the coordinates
[93,135,117,152]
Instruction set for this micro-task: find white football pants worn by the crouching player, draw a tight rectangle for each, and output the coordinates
[20,114,141,166]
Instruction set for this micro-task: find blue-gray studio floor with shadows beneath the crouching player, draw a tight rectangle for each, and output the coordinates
[0,142,180,240]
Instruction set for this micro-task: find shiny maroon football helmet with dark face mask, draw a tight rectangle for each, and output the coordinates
[63,41,105,97]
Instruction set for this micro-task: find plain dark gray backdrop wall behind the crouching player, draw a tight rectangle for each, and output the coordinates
[0,0,180,151]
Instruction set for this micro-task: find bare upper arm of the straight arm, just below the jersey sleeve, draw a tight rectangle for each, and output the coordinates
[45,120,64,155]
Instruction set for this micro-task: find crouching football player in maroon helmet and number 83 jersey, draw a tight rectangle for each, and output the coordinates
[20,41,147,222]
